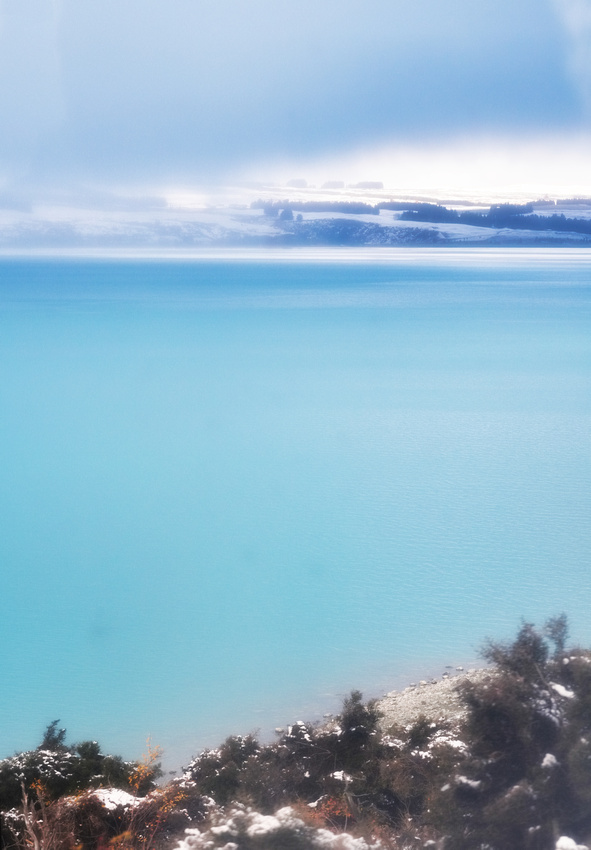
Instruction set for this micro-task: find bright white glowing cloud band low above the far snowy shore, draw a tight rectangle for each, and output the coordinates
[247,132,591,200]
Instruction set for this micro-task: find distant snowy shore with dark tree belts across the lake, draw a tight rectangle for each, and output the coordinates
[0,196,591,256]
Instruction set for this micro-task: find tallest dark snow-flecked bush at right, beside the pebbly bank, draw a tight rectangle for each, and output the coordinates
[430,617,591,850]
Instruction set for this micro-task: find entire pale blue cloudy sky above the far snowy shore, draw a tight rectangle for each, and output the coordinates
[0,0,591,200]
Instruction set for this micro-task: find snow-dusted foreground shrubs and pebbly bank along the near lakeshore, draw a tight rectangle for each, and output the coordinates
[0,615,591,850]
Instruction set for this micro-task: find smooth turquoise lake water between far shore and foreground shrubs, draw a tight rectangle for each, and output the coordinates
[0,251,591,767]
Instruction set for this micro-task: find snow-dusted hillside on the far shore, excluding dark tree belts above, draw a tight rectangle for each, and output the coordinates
[0,197,591,253]
